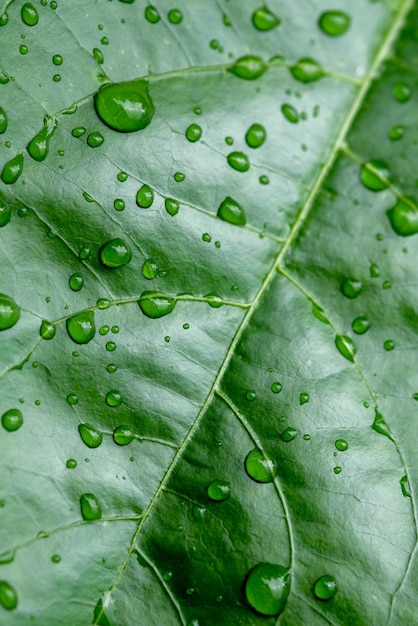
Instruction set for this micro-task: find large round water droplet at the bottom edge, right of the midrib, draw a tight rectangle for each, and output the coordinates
[245,563,290,616]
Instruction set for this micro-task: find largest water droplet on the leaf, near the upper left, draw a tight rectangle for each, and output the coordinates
[94,80,155,133]
